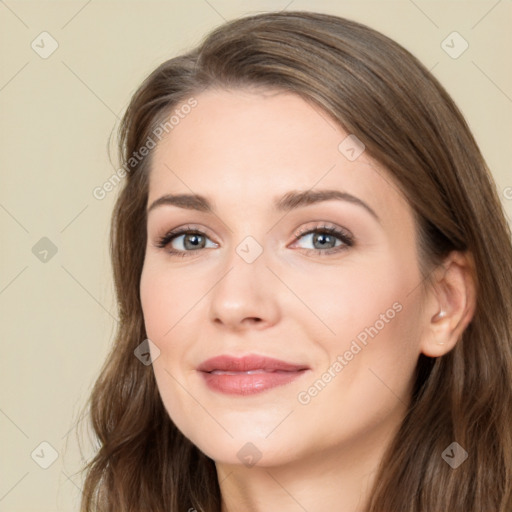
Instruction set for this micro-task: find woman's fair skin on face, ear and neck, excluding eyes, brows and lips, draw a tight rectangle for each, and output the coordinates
[140,90,474,512]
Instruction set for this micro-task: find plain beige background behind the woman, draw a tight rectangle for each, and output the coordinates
[0,0,512,512]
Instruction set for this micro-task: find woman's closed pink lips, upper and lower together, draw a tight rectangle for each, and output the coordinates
[197,354,309,395]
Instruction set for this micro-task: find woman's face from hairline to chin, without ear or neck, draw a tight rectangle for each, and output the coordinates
[140,90,428,466]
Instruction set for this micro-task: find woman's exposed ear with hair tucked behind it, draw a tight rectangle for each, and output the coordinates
[421,251,476,357]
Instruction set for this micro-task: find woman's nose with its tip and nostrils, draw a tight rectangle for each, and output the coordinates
[209,245,280,331]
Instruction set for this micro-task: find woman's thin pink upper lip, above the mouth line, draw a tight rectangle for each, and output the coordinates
[197,354,308,372]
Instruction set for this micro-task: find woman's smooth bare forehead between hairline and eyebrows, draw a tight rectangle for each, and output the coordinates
[148,89,406,223]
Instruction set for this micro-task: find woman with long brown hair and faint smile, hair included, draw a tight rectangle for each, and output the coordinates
[82,12,512,512]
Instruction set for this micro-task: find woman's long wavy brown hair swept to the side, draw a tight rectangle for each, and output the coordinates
[77,12,512,512]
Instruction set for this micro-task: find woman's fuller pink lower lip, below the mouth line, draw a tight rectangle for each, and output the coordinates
[201,370,306,395]
